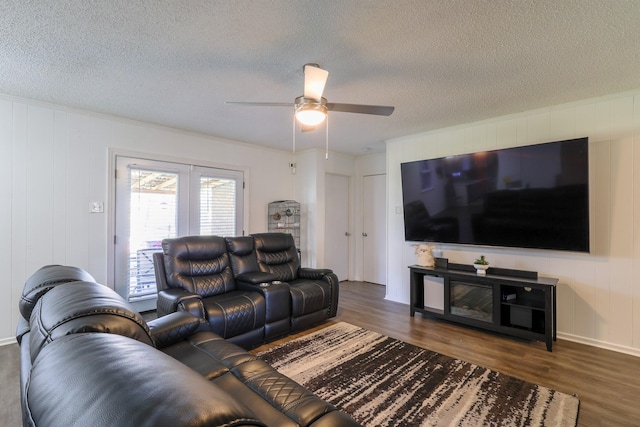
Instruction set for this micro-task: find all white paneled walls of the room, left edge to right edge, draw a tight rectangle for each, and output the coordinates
[7,85,640,355]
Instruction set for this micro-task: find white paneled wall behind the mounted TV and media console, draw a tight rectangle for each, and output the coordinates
[387,90,640,355]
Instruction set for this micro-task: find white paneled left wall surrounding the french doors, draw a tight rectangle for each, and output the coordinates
[0,96,296,344]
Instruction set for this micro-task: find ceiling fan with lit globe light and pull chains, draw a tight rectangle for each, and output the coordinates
[227,64,394,130]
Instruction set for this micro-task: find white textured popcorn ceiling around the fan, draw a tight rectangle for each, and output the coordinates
[0,0,640,154]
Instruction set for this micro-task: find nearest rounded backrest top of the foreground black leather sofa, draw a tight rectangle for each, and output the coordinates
[23,333,265,427]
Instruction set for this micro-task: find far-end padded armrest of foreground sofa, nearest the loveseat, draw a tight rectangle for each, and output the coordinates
[147,311,211,348]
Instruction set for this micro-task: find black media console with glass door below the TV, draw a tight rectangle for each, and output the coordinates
[409,263,558,351]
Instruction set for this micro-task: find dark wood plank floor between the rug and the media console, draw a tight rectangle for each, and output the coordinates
[257,282,640,427]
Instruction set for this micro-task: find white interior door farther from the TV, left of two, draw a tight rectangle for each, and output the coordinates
[324,174,350,280]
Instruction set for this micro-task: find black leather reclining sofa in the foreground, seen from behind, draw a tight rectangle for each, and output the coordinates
[16,266,358,427]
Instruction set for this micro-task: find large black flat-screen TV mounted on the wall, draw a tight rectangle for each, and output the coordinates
[401,138,589,252]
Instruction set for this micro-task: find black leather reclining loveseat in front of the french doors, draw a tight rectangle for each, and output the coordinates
[153,233,339,349]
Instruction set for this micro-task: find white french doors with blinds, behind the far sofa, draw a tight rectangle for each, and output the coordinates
[114,156,243,311]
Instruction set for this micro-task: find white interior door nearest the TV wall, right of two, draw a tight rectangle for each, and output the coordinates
[362,175,387,285]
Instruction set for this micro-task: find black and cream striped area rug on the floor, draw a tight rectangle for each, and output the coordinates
[258,323,579,426]
